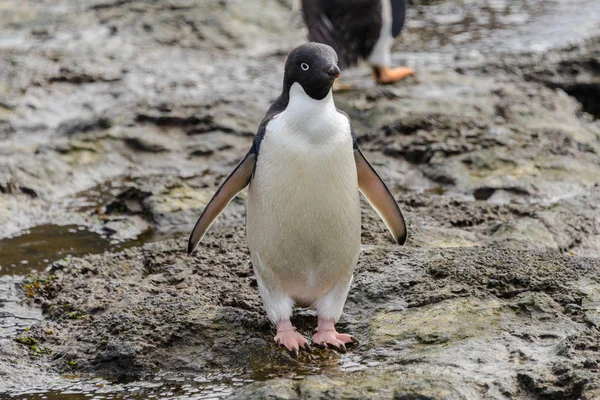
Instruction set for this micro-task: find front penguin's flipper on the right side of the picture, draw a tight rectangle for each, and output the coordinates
[354,146,406,244]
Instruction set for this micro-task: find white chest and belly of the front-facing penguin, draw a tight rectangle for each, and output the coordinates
[247,84,360,304]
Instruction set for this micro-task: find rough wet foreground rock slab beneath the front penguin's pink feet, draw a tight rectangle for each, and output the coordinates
[8,239,600,398]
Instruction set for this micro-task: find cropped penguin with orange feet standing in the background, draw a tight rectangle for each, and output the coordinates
[302,0,414,89]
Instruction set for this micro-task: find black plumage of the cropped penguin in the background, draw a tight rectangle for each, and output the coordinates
[302,0,406,68]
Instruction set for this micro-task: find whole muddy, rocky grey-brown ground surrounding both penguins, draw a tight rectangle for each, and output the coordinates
[0,0,600,399]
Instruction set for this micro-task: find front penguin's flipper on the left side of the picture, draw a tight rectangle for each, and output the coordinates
[188,151,256,254]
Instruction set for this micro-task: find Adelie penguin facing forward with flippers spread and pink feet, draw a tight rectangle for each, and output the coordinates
[188,43,406,354]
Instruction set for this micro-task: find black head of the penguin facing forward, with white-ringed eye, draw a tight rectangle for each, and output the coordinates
[283,42,340,100]
